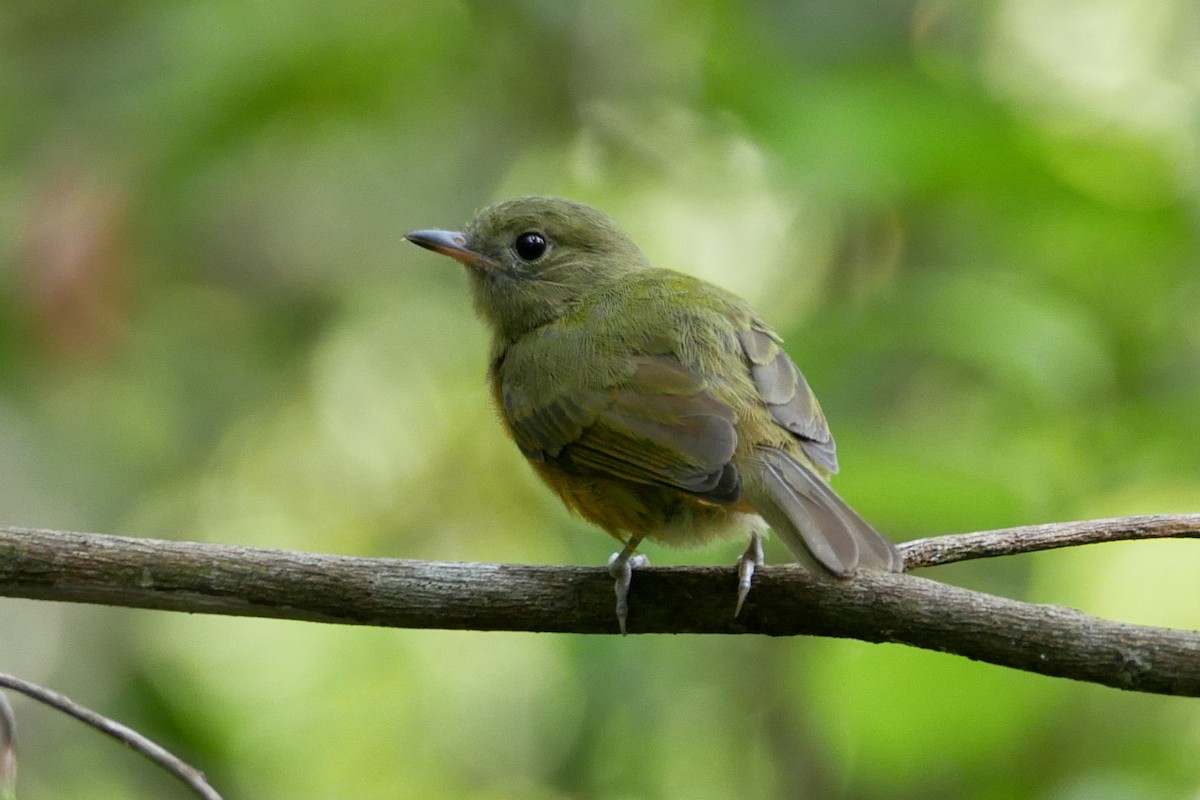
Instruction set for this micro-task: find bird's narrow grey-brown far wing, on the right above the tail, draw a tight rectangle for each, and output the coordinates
[738,326,838,473]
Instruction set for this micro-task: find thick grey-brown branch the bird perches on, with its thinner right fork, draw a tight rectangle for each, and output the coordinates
[0,515,1200,697]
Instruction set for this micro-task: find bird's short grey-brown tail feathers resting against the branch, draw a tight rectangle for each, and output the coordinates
[756,449,904,578]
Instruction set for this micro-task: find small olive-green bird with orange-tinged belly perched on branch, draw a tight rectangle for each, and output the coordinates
[407,197,904,632]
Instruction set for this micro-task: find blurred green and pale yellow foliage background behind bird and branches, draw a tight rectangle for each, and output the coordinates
[0,0,1200,800]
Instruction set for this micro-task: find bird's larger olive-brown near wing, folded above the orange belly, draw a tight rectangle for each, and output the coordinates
[498,355,742,503]
